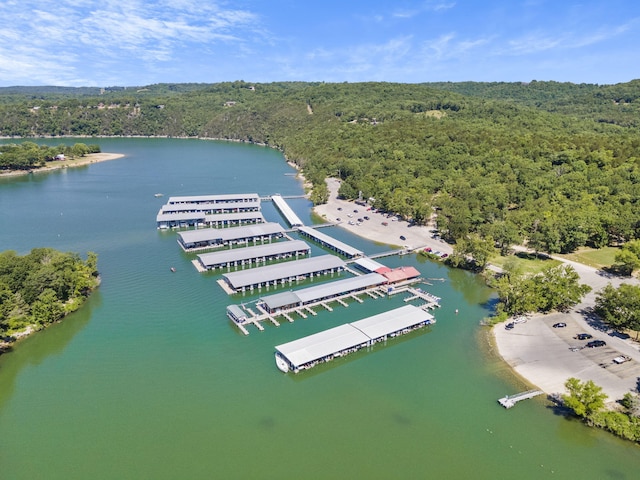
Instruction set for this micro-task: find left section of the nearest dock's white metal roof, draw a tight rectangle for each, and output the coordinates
[276,323,369,367]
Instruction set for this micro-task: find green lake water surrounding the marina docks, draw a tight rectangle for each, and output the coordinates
[0,139,640,479]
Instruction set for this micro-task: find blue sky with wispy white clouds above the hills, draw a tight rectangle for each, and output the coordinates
[0,0,640,87]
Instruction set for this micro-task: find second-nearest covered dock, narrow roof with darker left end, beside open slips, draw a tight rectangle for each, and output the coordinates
[258,273,387,313]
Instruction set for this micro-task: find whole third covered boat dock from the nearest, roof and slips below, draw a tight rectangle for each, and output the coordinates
[222,255,346,293]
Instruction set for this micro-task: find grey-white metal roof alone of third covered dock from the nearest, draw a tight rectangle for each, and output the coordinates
[223,255,346,288]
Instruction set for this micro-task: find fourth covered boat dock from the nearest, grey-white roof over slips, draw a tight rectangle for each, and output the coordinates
[198,240,311,270]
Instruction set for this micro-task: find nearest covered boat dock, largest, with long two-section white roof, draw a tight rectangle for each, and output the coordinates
[275,305,434,373]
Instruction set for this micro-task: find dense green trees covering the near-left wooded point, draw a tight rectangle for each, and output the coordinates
[0,248,99,343]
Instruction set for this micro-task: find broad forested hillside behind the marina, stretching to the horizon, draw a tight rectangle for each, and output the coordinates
[0,81,640,252]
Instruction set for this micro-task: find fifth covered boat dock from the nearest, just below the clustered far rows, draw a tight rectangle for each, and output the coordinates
[178,222,284,252]
